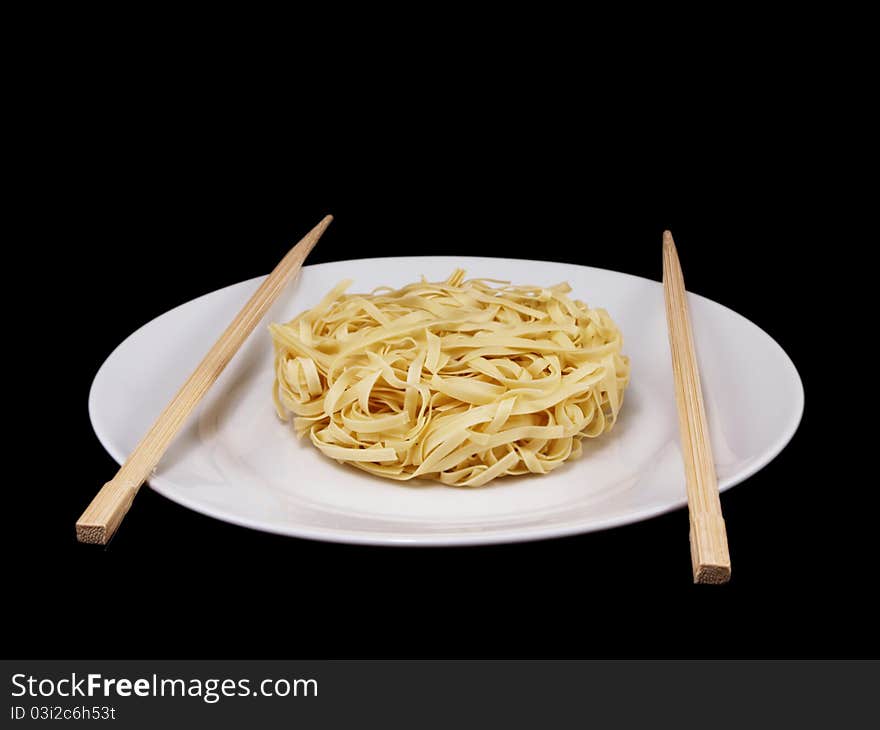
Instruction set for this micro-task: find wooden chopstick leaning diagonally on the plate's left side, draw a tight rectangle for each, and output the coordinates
[76,215,333,545]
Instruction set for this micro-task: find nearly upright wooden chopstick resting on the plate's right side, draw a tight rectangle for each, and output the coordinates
[663,231,730,583]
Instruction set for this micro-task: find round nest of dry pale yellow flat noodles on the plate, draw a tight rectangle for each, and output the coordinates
[270,269,629,487]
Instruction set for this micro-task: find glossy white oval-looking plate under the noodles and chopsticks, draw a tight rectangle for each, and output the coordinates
[89,256,804,545]
